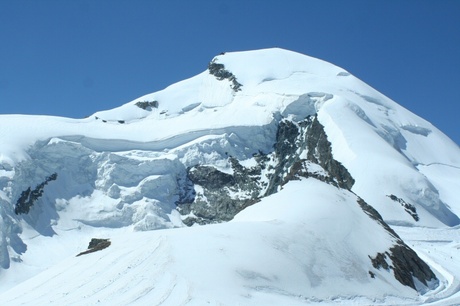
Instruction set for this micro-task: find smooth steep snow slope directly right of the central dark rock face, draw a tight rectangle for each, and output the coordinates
[318,85,460,226]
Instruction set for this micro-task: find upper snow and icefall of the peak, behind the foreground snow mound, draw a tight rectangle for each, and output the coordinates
[0,49,460,298]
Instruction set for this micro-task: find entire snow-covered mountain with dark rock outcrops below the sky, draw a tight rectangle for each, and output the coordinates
[0,49,460,305]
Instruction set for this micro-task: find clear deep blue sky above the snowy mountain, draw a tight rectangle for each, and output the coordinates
[0,0,460,144]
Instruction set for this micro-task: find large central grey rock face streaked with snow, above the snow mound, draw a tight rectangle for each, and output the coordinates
[178,116,354,225]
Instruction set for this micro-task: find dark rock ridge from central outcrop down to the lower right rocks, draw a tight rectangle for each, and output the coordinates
[174,116,438,292]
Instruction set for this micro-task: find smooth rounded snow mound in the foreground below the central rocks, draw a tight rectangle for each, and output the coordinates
[0,179,434,305]
